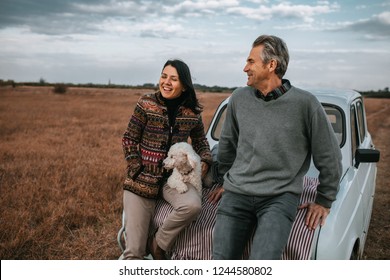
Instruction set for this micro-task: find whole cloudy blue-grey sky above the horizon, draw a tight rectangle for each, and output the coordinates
[0,0,390,90]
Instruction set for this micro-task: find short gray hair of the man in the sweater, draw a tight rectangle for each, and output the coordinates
[252,35,290,79]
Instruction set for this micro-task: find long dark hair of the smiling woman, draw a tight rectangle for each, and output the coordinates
[163,59,203,114]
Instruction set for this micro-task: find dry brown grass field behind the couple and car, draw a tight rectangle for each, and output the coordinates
[0,87,390,260]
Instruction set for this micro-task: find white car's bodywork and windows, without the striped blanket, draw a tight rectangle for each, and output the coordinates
[207,89,380,260]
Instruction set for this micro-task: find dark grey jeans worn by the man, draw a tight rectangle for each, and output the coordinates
[213,190,299,260]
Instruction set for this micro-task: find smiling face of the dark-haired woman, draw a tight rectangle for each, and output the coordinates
[159,65,184,99]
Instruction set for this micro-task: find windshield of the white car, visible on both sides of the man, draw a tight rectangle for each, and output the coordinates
[211,104,345,147]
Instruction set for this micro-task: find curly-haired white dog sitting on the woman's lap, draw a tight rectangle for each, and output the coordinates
[163,142,202,194]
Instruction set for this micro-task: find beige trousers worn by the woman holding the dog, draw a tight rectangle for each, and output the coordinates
[123,185,202,259]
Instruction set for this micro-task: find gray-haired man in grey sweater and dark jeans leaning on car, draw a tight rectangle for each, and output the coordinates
[213,35,341,259]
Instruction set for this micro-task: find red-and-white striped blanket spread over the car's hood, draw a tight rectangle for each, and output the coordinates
[150,177,318,260]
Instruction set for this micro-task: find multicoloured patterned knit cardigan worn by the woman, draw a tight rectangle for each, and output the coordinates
[122,92,212,198]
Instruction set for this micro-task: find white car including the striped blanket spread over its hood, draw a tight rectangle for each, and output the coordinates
[118,89,380,260]
